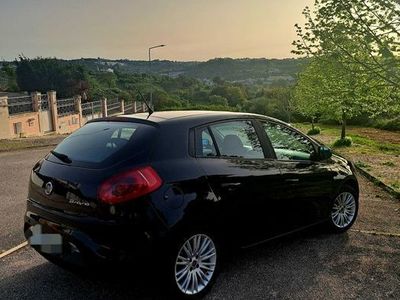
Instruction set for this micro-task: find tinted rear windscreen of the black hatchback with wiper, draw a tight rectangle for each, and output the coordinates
[51,121,156,167]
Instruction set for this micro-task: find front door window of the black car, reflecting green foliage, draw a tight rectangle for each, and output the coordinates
[263,122,315,160]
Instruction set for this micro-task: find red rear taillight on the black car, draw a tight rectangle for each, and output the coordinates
[98,166,162,204]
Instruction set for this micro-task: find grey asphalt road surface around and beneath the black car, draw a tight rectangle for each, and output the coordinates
[0,149,400,299]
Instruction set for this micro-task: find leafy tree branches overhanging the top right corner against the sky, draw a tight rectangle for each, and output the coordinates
[293,0,400,87]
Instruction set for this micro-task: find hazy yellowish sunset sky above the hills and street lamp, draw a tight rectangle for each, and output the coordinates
[0,0,313,61]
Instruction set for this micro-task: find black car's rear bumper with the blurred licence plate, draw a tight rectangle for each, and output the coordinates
[24,200,159,263]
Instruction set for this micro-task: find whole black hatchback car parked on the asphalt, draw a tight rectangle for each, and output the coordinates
[24,111,359,298]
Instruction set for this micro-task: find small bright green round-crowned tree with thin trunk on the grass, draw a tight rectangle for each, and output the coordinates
[294,57,391,139]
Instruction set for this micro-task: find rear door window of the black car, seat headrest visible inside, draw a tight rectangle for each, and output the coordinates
[210,121,264,159]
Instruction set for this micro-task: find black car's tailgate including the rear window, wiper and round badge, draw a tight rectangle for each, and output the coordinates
[29,121,157,216]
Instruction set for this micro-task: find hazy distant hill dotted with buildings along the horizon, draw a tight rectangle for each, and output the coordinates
[72,58,307,84]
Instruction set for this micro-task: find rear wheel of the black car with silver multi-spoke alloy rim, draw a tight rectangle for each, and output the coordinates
[167,231,221,299]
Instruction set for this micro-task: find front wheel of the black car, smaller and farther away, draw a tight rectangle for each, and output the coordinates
[328,185,359,233]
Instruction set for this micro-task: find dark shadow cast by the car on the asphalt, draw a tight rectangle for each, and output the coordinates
[0,229,348,299]
